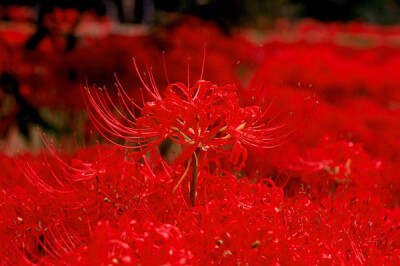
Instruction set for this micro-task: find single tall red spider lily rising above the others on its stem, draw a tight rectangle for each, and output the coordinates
[84,56,314,205]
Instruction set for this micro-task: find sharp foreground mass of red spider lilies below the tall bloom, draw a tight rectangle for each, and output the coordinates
[1,137,400,264]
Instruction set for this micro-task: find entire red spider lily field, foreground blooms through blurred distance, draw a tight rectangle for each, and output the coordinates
[0,8,400,265]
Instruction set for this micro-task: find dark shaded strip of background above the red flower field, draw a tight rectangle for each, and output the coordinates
[0,0,400,28]
